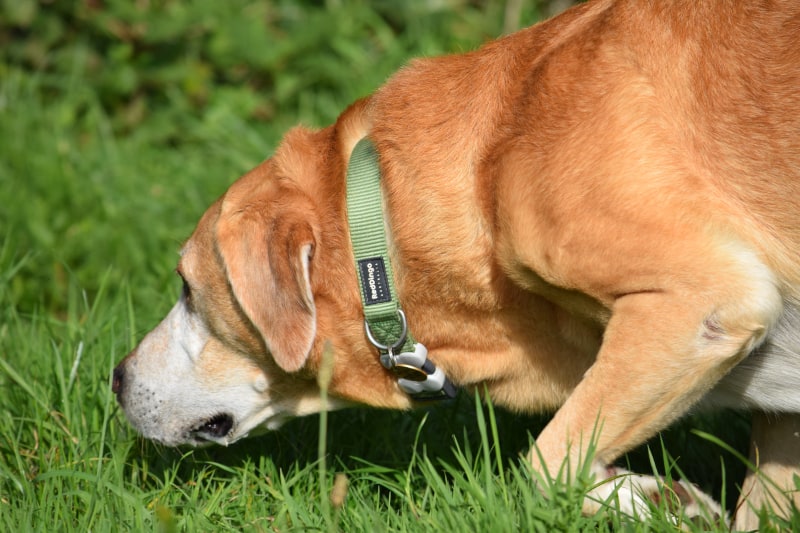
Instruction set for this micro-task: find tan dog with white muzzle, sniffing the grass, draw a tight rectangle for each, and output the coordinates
[113,0,800,526]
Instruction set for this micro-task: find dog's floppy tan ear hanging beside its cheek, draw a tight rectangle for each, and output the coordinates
[216,197,316,372]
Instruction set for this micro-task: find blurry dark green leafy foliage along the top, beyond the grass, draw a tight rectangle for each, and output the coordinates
[0,0,563,142]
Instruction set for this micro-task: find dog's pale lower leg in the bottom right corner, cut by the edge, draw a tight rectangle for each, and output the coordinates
[735,413,800,531]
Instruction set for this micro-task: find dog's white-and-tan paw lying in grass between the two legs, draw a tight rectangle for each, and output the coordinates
[587,467,728,527]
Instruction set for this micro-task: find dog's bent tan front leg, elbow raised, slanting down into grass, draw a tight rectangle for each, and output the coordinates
[530,276,782,514]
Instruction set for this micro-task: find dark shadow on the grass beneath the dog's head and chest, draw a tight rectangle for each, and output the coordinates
[119,393,749,509]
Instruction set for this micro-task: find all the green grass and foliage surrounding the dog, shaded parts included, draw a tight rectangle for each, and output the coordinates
[0,0,777,532]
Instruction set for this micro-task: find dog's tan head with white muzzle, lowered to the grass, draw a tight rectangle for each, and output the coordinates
[113,121,407,445]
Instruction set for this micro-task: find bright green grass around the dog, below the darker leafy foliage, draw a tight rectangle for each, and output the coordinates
[0,2,788,532]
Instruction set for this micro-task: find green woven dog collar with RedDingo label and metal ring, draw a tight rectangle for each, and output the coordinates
[347,137,456,399]
